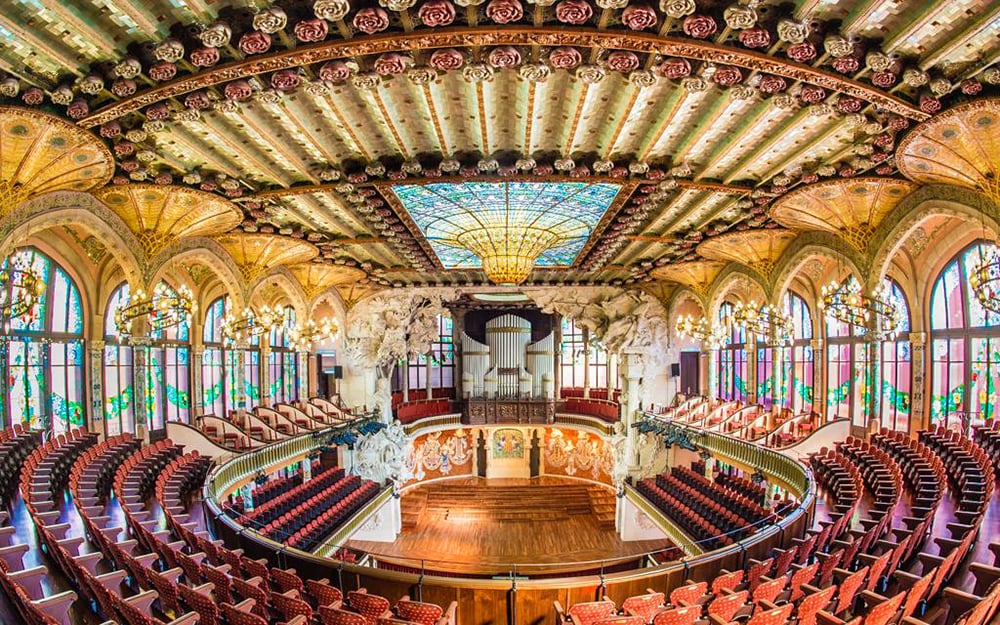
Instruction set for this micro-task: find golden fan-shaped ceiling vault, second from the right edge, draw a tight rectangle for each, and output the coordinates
[771,178,917,252]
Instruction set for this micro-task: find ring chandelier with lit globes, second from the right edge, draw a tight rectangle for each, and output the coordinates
[821,280,905,341]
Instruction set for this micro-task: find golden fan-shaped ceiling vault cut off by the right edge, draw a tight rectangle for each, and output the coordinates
[896,98,1000,211]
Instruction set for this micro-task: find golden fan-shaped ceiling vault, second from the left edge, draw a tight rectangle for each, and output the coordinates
[96,184,242,259]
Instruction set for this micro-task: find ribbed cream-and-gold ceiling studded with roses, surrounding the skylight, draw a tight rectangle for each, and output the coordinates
[0,0,1000,286]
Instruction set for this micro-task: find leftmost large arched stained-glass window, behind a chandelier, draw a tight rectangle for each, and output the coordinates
[0,247,86,434]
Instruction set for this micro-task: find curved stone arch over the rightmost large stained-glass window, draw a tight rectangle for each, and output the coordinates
[872,184,1000,284]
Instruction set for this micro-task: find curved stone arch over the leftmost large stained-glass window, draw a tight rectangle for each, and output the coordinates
[0,191,144,284]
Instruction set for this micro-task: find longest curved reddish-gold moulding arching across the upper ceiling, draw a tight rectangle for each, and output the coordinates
[79,26,930,128]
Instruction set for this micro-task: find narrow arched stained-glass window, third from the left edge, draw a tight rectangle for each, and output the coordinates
[201,296,238,418]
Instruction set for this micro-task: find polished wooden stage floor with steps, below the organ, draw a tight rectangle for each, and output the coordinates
[347,477,673,575]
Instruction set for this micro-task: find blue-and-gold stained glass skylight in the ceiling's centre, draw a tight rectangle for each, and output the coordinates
[392,182,621,278]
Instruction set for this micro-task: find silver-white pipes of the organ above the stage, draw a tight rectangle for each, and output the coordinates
[461,313,555,398]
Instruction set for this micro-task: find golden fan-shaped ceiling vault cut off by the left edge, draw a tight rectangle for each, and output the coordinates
[0,106,115,217]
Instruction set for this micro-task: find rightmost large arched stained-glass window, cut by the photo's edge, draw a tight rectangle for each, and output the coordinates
[931,243,1000,429]
